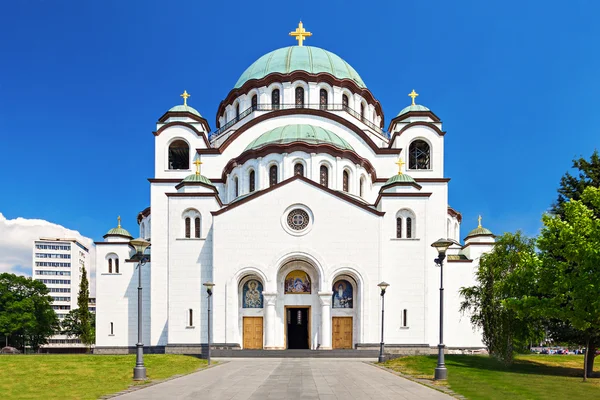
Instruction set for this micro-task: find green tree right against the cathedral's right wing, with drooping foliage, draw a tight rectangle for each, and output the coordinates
[460,232,541,364]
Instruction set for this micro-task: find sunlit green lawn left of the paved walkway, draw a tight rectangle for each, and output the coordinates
[0,354,206,400]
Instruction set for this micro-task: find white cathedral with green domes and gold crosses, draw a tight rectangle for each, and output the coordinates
[95,24,494,353]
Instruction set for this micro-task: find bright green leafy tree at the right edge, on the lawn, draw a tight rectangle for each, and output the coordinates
[536,187,600,379]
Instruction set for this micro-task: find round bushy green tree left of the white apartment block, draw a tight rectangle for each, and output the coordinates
[0,273,59,351]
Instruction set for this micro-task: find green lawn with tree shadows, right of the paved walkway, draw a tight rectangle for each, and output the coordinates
[383,355,600,400]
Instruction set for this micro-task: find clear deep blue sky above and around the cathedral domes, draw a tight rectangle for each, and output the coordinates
[0,0,600,240]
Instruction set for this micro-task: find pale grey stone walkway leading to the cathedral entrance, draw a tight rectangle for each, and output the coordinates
[116,358,452,400]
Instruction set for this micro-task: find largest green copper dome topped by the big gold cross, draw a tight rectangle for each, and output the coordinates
[235,46,366,88]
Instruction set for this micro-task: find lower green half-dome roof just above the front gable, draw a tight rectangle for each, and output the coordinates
[244,124,354,151]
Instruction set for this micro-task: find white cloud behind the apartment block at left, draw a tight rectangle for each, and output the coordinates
[0,213,95,276]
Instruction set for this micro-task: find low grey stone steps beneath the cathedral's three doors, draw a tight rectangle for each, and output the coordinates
[209,349,379,358]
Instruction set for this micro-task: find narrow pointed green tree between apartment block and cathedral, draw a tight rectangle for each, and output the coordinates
[61,267,95,346]
